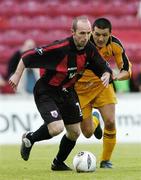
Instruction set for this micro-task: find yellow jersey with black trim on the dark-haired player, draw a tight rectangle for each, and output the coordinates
[79,36,131,82]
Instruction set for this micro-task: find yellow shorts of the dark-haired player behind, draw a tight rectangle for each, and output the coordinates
[75,82,117,119]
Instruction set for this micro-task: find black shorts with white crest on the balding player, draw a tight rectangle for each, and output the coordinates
[34,79,82,125]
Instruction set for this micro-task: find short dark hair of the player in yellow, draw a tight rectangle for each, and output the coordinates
[92,18,112,33]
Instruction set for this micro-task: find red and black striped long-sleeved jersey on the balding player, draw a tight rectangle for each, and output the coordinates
[22,36,111,88]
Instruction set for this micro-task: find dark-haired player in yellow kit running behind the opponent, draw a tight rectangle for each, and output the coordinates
[75,18,131,168]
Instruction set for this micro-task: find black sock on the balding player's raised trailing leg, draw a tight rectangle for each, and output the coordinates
[27,124,52,144]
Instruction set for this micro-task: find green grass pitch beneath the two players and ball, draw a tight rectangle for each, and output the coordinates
[0,144,141,180]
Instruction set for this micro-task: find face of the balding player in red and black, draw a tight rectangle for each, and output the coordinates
[72,21,91,49]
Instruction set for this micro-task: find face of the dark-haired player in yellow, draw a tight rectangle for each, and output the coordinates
[92,26,111,48]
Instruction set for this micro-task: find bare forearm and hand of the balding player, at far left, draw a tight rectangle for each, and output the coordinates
[9,59,25,91]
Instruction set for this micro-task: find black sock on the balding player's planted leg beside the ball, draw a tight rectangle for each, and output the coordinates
[56,135,76,162]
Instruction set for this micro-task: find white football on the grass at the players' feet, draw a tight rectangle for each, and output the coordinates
[73,151,96,172]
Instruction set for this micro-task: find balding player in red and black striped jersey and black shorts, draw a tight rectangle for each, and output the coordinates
[9,16,112,171]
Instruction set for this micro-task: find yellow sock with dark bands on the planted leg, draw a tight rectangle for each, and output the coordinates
[101,129,116,161]
